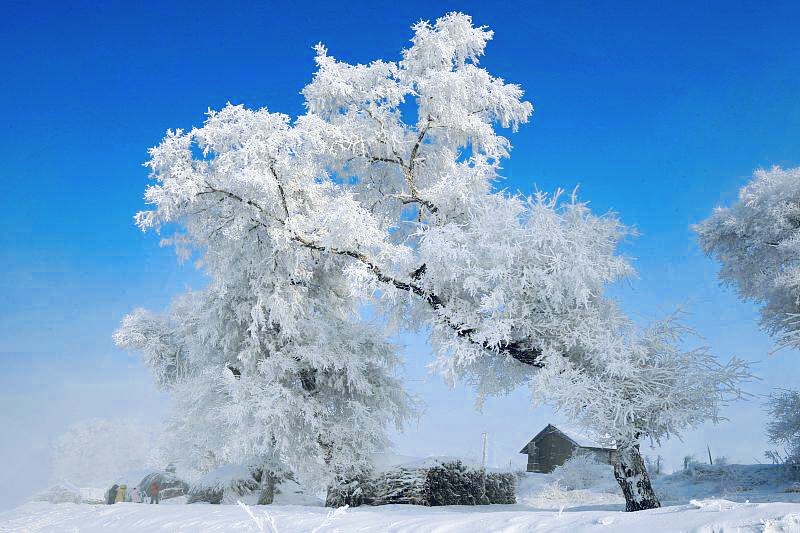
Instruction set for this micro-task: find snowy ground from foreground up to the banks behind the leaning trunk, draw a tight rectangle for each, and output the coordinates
[0,465,800,533]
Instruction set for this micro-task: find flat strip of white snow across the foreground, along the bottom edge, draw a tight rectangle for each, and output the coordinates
[0,500,800,533]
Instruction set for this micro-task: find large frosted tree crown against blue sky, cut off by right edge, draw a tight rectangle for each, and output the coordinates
[694,167,800,347]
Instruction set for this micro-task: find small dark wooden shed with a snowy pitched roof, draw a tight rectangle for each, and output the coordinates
[519,424,617,474]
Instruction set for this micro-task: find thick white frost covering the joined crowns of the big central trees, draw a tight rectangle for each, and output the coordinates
[116,9,752,508]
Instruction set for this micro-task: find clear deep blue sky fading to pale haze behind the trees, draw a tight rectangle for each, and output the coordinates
[0,1,800,508]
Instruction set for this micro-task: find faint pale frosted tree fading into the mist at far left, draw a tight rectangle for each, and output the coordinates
[50,418,160,487]
